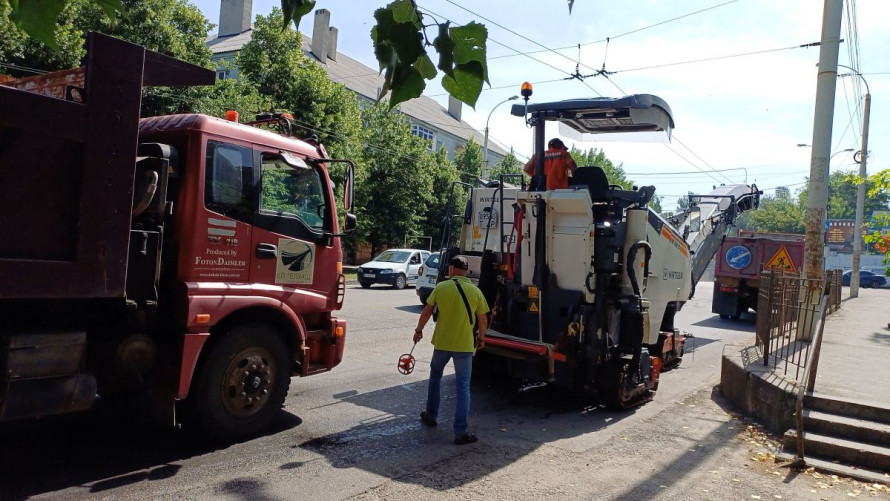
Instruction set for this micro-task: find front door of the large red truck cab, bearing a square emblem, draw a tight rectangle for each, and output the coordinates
[250,151,336,292]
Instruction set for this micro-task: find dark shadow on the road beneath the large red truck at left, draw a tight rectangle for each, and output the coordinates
[0,394,302,501]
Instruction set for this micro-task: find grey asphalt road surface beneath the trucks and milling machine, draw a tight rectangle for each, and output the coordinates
[0,283,876,501]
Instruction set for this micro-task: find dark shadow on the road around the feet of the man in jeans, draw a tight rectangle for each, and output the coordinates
[294,376,634,491]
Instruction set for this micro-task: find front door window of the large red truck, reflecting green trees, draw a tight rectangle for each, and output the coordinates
[260,158,326,228]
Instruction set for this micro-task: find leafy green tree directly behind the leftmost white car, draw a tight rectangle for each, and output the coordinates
[356,103,436,254]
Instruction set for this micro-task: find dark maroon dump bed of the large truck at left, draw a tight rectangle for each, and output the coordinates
[0,33,214,300]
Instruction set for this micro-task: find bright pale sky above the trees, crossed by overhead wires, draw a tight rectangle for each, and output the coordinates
[194,0,890,208]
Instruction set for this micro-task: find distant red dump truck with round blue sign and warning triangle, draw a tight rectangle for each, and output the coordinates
[711,230,804,320]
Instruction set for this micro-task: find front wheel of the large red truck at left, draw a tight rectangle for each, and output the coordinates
[193,323,290,442]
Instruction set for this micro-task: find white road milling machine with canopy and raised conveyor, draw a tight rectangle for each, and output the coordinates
[440,94,759,408]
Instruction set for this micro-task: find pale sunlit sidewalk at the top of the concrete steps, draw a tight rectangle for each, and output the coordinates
[814,287,890,406]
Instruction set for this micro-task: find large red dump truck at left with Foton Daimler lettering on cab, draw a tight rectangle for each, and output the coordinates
[0,33,355,440]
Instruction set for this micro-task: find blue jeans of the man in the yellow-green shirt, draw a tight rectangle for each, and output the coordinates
[426,350,473,437]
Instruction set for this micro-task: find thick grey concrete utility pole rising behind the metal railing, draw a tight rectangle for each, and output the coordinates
[804,0,843,284]
